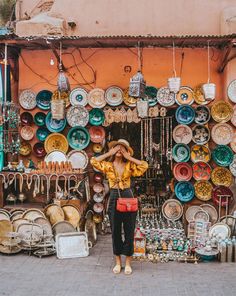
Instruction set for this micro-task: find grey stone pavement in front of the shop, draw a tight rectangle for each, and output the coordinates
[0,236,236,296]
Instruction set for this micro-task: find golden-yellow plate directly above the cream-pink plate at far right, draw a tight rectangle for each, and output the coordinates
[211,101,233,123]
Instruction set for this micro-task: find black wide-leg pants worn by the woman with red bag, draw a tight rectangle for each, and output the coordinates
[108,189,137,256]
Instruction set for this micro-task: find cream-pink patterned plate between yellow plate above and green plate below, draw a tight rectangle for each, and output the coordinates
[211,123,234,145]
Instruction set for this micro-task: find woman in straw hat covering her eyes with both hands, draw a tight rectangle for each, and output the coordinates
[91,139,148,274]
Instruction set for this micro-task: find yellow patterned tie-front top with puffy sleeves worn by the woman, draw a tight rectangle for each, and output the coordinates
[90,157,148,189]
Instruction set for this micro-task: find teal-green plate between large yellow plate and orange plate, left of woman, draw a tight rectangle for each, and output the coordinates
[67,126,90,150]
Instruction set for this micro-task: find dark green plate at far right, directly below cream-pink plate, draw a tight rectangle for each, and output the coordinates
[212,145,234,167]
